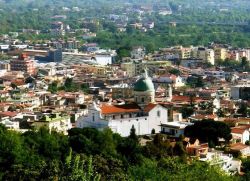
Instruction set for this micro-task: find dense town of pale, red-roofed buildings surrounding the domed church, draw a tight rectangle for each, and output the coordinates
[0,36,250,173]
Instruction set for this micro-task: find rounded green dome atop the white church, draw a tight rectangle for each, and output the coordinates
[134,77,155,92]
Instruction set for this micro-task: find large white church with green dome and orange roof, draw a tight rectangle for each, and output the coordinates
[76,71,170,137]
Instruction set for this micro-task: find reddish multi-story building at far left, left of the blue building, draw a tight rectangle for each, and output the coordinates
[10,54,35,75]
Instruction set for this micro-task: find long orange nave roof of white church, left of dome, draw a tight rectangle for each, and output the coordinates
[100,104,140,114]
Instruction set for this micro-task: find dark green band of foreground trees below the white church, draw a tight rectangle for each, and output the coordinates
[0,125,238,181]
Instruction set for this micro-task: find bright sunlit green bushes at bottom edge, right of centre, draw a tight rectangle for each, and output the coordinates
[129,157,234,181]
